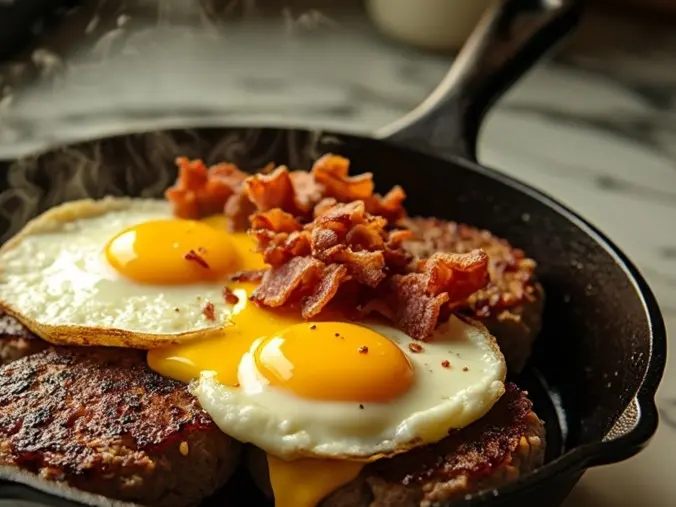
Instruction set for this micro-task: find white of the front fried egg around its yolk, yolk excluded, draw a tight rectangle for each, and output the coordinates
[191,317,506,460]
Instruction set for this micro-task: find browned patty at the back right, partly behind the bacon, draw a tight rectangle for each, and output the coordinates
[402,218,544,373]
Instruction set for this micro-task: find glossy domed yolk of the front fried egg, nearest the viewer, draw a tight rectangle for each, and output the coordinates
[254,322,414,403]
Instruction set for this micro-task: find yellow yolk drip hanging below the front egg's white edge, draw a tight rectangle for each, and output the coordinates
[268,455,364,507]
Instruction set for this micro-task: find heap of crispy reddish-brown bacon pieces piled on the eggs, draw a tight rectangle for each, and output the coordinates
[166,154,489,339]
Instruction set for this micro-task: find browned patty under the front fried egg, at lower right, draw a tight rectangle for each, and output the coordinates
[247,384,545,507]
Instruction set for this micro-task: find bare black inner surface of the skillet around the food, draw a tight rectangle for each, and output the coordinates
[0,129,652,505]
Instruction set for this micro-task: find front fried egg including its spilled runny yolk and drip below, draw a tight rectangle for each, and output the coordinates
[148,266,506,507]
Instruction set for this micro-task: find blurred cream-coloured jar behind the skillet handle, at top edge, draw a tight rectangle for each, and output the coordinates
[367,0,491,50]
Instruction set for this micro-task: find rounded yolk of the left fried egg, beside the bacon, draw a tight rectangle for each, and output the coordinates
[105,220,242,285]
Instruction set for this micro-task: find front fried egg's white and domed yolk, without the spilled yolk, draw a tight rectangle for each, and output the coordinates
[192,317,506,461]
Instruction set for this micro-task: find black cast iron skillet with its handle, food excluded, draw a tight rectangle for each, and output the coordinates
[0,0,666,506]
